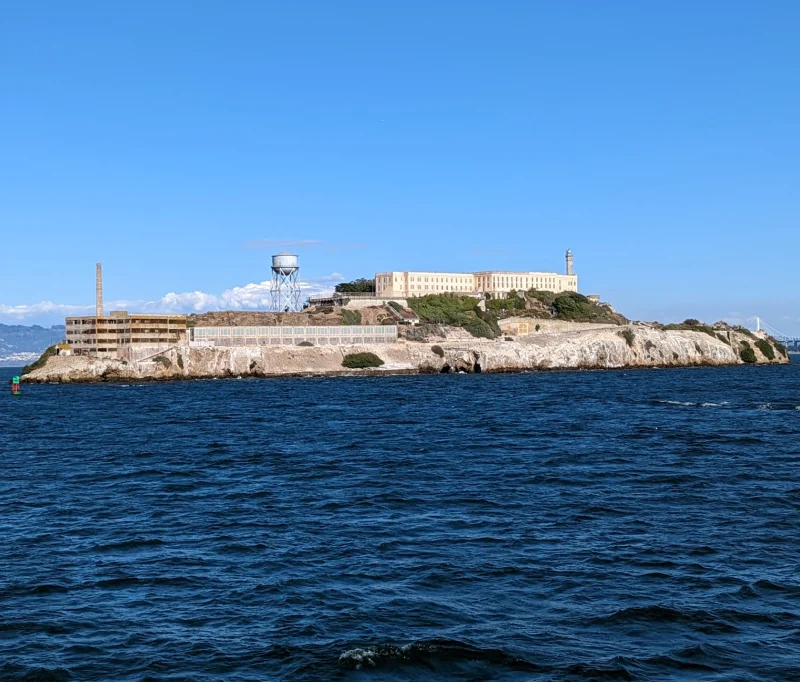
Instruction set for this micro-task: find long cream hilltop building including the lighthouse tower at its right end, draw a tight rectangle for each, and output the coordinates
[375,251,578,298]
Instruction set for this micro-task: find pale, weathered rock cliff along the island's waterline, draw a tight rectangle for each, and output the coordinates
[24,325,788,383]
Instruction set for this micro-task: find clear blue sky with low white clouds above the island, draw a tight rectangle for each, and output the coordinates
[0,1,800,333]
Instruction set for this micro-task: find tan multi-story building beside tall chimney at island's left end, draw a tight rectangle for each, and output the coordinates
[65,310,186,358]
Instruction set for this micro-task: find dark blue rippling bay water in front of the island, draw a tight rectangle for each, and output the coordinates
[0,366,800,681]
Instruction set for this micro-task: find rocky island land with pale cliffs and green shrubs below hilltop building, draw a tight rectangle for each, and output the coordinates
[17,290,789,383]
